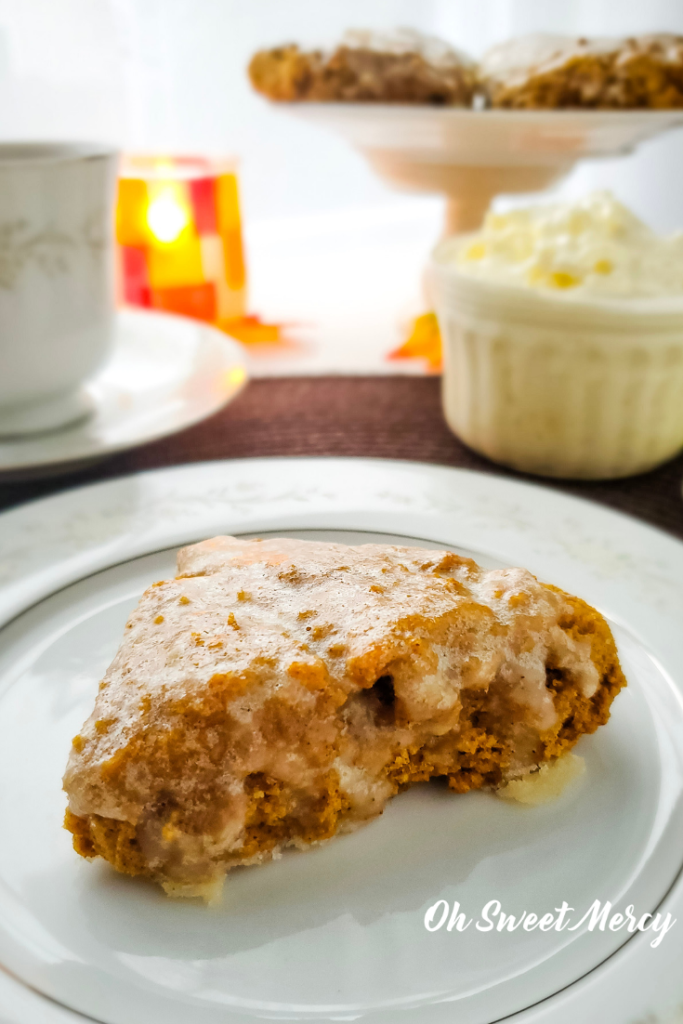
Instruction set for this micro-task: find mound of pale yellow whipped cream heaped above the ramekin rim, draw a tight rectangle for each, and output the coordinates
[452,191,683,299]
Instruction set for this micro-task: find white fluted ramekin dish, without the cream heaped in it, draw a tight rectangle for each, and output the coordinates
[430,237,683,479]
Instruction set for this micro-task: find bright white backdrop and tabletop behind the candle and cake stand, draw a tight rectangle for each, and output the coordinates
[0,0,683,372]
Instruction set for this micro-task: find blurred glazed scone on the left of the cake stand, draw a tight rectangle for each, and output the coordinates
[249,29,476,106]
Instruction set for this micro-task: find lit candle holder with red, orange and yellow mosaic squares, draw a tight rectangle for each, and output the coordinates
[117,156,247,326]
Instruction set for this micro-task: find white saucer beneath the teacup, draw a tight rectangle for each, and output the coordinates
[0,309,247,477]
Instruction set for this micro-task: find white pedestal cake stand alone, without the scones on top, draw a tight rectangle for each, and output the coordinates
[286,102,683,234]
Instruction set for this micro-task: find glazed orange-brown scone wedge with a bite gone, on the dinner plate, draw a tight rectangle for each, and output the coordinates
[63,537,625,897]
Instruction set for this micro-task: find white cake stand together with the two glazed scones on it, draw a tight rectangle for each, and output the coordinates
[249,30,683,234]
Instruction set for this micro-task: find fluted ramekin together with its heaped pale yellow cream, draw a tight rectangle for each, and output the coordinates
[431,193,683,479]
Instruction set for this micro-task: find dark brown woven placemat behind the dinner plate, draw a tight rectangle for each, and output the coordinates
[0,377,683,538]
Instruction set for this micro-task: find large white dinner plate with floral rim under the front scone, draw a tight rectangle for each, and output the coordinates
[0,459,683,1024]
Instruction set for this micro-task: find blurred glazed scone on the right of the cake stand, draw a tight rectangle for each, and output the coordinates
[479,34,683,110]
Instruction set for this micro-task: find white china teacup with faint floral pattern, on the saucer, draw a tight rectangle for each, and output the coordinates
[0,142,118,435]
